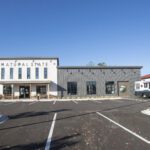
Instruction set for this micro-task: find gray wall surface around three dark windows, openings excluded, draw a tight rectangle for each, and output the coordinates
[58,67,141,97]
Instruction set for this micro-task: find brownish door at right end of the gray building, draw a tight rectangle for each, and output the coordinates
[118,81,129,97]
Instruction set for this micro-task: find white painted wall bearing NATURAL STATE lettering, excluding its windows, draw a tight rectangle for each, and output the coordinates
[0,59,58,96]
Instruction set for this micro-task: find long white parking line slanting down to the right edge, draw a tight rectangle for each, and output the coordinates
[96,112,150,144]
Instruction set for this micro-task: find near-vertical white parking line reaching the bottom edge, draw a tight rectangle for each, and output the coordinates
[45,113,57,150]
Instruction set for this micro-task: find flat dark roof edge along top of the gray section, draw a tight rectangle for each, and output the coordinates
[58,66,143,69]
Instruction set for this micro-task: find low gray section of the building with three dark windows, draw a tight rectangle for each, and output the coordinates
[58,66,142,97]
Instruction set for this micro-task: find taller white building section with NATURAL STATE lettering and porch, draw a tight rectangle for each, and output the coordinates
[0,57,59,99]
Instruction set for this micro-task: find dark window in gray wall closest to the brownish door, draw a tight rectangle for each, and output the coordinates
[105,81,115,94]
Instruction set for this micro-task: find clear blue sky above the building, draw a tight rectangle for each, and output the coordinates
[0,0,150,75]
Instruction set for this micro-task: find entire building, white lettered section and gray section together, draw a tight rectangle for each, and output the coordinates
[0,57,142,99]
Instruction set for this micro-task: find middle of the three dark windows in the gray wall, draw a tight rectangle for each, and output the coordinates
[86,81,96,95]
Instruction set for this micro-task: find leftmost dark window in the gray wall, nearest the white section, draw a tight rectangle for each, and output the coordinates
[67,82,77,95]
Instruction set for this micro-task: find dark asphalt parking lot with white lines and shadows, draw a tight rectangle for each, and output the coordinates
[0,99,150,150]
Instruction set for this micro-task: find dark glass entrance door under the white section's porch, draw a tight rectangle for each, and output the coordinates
[19,86,30,98]
